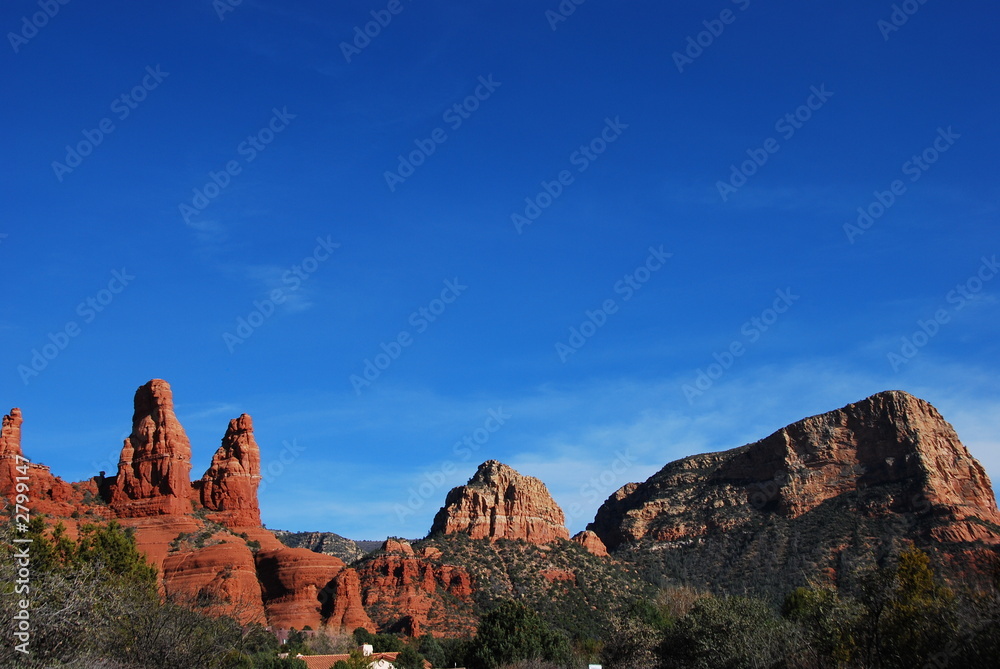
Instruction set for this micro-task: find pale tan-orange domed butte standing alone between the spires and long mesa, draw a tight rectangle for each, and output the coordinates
[431,460,569,544]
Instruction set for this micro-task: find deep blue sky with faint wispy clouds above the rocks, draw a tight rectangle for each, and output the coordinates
[0,0,1000,539]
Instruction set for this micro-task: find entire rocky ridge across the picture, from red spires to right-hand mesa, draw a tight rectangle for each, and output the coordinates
[0,380,1000,635]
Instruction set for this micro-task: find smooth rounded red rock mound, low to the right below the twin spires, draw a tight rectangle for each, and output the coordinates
[256,548,375,632]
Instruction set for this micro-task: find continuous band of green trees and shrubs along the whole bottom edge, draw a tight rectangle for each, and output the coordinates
[0,518,1000,669]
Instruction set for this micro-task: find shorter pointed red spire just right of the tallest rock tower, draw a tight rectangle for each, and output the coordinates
[193,414,261,527]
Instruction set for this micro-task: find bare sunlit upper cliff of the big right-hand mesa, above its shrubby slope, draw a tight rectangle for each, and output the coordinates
[588,391,1000,550]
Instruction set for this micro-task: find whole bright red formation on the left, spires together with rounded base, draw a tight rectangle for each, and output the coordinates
[0,379,376,632]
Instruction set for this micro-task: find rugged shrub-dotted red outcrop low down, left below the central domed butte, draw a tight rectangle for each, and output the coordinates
[358,539,475,635]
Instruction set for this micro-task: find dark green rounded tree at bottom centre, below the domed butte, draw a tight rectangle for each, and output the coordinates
[469,601,570,669]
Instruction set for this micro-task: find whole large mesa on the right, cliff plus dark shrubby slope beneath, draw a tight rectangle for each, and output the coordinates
[589,391,1000,586]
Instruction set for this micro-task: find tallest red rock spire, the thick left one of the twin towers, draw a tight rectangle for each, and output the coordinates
[106,379,191,518]
